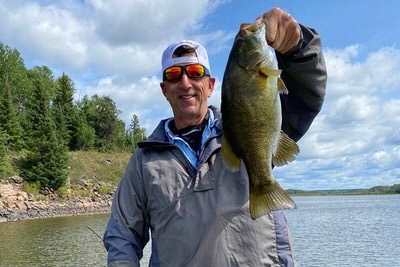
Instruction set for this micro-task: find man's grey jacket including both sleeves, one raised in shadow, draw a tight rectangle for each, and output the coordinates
[104,27,326,267]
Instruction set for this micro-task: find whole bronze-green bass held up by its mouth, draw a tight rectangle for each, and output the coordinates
[221,23,299,219]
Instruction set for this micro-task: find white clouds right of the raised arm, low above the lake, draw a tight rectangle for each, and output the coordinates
[276,45,400,189]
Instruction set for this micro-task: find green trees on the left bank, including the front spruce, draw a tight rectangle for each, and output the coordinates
[0,42,146,189]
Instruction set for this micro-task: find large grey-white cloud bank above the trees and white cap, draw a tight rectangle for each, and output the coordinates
[0,0,225,80]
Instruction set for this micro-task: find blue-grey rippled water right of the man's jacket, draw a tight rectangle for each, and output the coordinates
[285,195,400,267]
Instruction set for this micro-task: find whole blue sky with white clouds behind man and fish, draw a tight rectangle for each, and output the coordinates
[0,0,400,190]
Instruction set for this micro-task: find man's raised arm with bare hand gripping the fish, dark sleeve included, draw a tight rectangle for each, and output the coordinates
[257,8,327,141]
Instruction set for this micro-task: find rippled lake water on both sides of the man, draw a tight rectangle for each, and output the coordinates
[0,195,400,267]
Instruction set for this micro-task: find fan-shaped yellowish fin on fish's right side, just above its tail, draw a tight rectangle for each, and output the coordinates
[272,131,300,166]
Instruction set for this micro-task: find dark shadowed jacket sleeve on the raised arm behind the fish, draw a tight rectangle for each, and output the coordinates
[277,25,327,141]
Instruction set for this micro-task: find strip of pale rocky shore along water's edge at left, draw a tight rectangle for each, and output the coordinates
[0,178,113,222]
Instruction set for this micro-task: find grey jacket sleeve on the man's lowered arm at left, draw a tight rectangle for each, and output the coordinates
[103,153,149,267]
